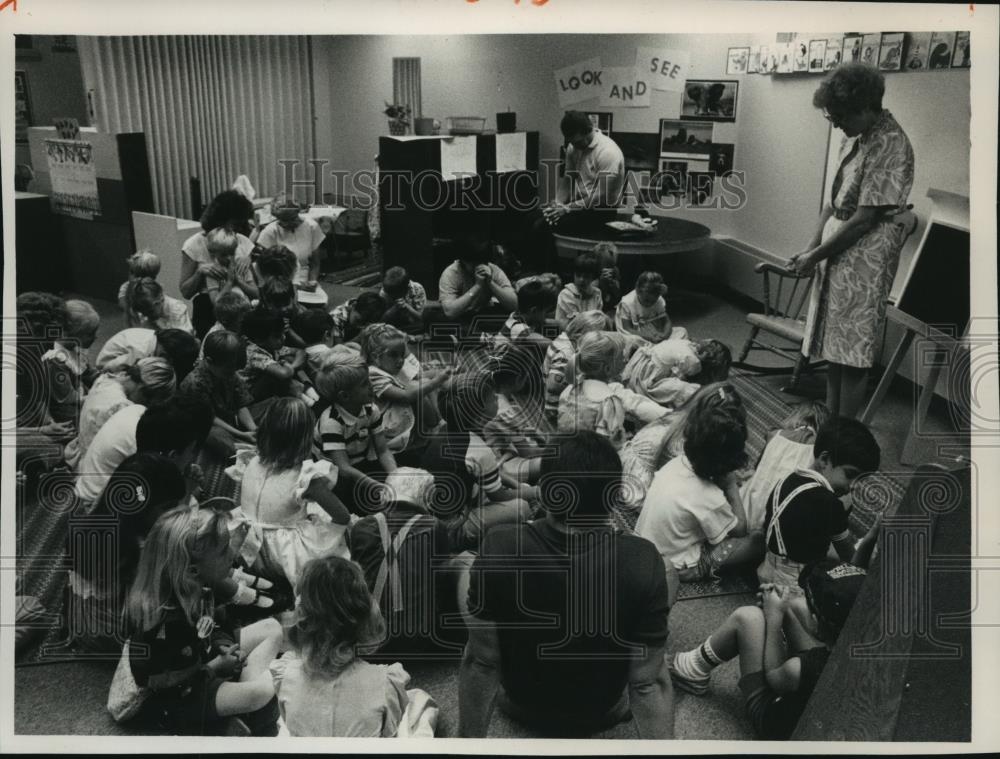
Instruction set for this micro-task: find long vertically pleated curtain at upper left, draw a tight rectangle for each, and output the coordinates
[78,36,313,218]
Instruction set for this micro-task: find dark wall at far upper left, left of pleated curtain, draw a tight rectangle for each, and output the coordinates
[14,35,90,165]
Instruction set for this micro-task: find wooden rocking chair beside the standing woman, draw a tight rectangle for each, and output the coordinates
[737,263,824,393]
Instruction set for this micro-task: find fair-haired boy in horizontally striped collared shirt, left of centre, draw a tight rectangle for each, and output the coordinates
[316,350,396,514]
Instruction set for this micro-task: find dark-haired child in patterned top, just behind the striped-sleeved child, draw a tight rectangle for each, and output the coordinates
[483,346,545,487]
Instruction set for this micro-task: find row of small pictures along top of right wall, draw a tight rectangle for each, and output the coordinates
[726,32,972,76]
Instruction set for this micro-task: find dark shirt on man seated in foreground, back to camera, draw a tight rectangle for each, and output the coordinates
[469,521,669,724]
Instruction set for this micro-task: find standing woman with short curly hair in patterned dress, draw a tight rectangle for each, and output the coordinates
[789,63,913,417]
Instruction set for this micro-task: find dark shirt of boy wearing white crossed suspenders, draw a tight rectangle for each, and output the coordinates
[764,472,850,564]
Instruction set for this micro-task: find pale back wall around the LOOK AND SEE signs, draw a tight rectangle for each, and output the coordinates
[313,34,969,257]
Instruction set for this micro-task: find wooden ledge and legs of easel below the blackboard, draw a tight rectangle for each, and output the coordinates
[861,306,964,464]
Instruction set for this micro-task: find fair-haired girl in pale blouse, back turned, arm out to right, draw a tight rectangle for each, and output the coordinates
[558,332,668,451]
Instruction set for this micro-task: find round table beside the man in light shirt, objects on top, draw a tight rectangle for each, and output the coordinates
[552,216,712,294]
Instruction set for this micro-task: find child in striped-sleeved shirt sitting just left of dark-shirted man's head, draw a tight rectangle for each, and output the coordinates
[421,370,538,550]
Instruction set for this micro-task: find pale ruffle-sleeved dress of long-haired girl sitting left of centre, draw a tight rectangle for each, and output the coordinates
[230,456,351,588]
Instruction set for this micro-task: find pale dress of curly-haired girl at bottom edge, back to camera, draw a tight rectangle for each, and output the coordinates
[270,651,438,738]
